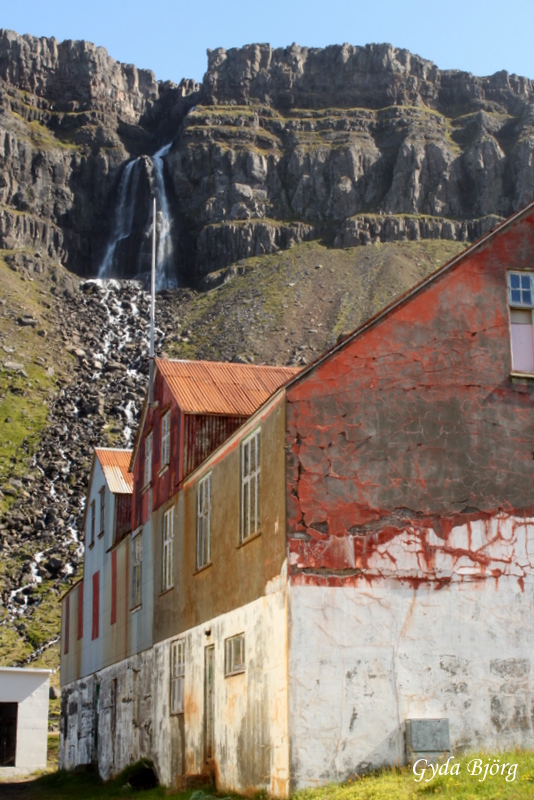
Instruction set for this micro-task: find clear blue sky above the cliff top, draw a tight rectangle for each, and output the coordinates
[0,0,534,82]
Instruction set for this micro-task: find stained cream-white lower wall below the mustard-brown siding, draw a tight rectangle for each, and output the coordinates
[154,576,289,797]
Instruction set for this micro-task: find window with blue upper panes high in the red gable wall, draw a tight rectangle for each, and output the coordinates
[508,272,534,373]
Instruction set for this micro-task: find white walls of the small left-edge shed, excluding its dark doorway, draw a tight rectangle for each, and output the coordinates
[0,667,50,770]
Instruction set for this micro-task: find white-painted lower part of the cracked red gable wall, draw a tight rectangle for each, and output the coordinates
[289,518,534,789]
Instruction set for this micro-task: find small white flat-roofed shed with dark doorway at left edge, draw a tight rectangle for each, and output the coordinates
[0,667,52,772]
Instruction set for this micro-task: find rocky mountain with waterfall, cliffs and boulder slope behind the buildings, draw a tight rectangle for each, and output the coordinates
[0,31,534,666]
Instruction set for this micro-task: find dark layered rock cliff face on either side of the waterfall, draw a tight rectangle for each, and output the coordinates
[0,31,534,281]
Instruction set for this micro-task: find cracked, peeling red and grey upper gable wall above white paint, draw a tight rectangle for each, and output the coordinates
[287,213,534,585]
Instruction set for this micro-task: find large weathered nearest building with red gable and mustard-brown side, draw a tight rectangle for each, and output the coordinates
[61,206,534,796]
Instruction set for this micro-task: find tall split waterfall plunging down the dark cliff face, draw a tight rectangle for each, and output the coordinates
[98,142,176,291]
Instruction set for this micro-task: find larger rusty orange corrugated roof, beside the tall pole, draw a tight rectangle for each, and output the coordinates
[156,358,300,416]
